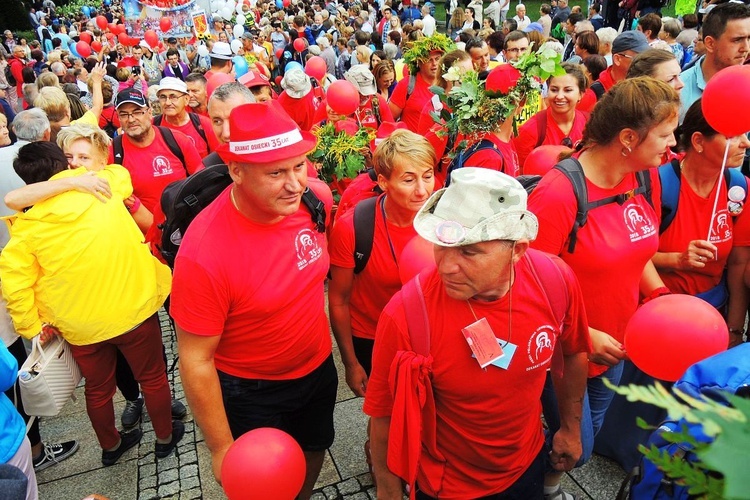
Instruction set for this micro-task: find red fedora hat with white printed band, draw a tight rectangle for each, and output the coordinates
[216,101,317,163]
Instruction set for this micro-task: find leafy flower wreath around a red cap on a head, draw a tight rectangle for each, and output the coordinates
[430,46,565,144]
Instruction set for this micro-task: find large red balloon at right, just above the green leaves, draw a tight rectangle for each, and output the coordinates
[625,294,729,382]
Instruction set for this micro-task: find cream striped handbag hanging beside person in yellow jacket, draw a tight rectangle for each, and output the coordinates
[18,335,81,417]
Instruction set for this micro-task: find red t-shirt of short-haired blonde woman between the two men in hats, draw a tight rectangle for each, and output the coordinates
[331,195,417,339]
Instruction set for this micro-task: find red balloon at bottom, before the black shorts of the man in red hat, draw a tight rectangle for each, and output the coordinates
[221,427,306,500]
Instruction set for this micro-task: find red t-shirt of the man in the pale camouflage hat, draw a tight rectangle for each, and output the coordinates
[364,258,590,499]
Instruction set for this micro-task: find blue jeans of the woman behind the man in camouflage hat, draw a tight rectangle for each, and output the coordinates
[542,363,624,471]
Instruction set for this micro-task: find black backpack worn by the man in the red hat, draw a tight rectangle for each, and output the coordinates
[159,164,326,267]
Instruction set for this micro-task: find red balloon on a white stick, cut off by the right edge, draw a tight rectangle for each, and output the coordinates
[701,66,750,137]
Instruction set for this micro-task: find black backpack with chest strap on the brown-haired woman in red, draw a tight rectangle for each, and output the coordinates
[516,158,653,253]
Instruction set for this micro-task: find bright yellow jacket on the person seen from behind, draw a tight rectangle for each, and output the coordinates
[0,165,172,345]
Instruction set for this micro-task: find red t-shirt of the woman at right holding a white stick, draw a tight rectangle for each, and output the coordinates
[654,172,750,295]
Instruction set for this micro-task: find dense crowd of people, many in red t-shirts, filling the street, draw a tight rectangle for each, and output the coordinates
[0,0,750,500]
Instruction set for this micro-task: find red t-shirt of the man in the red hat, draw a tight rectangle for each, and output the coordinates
[170,179,333,380]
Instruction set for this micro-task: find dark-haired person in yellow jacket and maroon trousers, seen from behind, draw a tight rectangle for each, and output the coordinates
[0,142,184,466]
